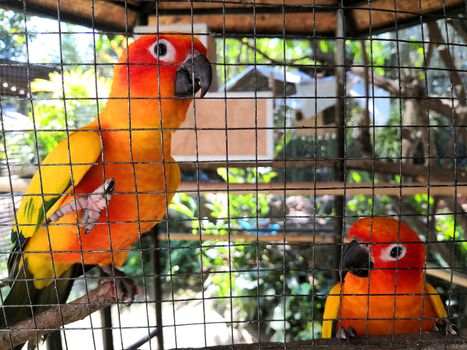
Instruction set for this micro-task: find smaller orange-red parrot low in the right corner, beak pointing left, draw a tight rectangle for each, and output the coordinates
[322,217,458,340]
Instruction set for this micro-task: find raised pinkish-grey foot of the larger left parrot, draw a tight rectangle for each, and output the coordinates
[47,178,115,235]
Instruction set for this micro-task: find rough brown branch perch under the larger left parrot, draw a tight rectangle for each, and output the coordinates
[0,282,117,349]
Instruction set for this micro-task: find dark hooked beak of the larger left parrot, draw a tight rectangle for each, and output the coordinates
[175,52,212,97]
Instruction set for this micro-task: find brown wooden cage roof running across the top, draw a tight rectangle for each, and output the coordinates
[0,0,465,36]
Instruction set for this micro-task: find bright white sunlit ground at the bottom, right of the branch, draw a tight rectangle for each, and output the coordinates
[57,296,260,350]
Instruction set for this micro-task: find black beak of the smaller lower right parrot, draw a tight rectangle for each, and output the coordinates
[342,240,373,277]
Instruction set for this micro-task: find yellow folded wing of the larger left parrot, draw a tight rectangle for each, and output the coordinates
[8,124,102,278]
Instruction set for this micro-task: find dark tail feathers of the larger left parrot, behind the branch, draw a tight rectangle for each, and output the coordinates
[0,264,83,350]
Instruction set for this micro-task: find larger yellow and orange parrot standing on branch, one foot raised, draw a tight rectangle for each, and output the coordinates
[0,34,212,334]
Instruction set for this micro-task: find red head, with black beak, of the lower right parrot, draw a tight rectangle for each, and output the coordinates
[342,217,426,277]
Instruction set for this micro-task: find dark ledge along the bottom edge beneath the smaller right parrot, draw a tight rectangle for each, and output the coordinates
[179,332,467,350]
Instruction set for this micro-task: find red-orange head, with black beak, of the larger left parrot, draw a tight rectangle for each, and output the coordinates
[112,34,212,98]
